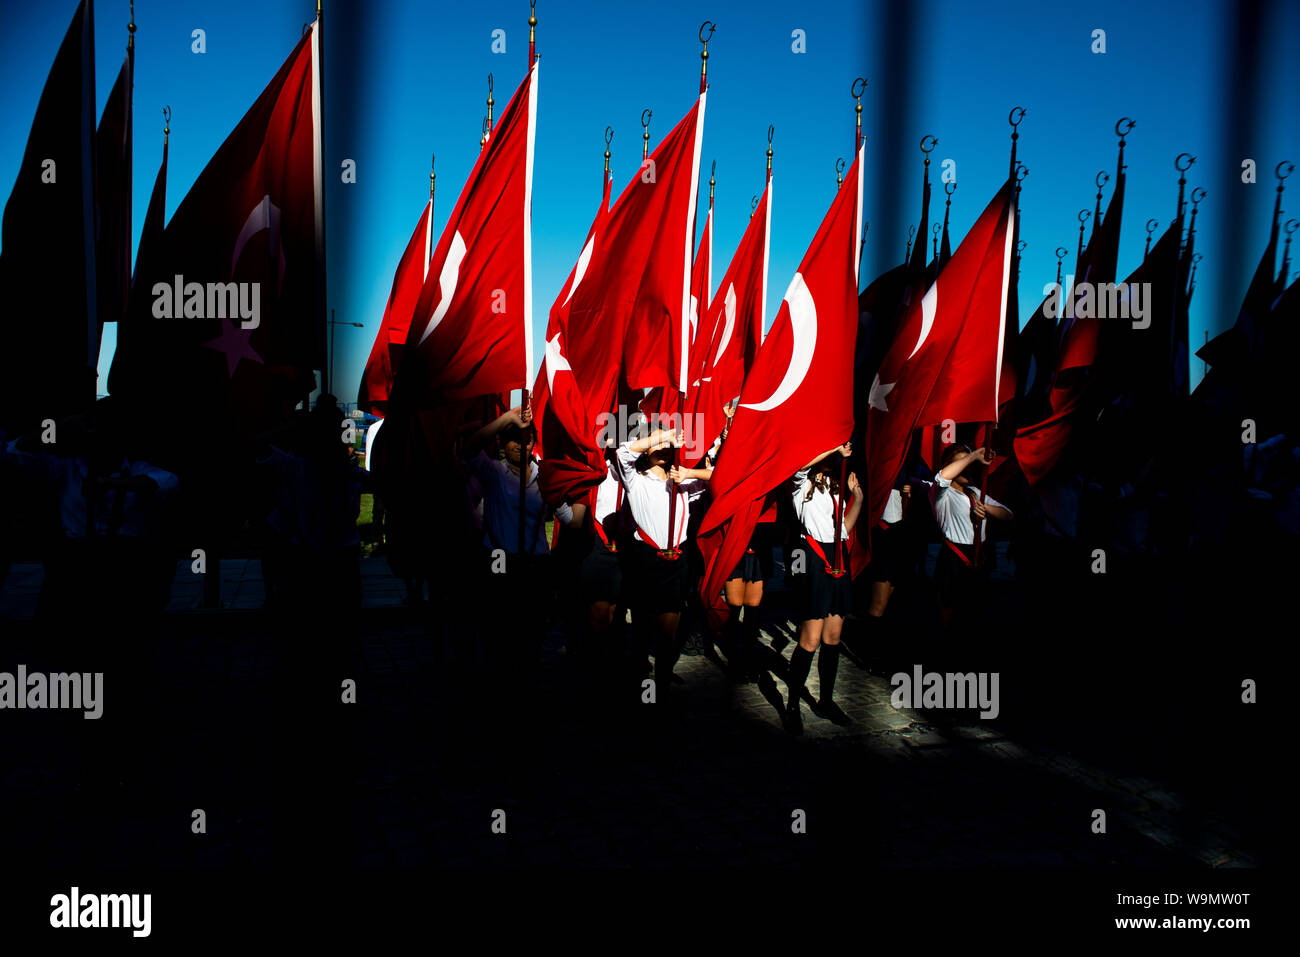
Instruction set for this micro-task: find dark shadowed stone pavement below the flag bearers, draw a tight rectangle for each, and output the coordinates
[0,546,1265,867]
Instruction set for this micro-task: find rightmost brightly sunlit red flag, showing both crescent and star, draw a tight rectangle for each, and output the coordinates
[855,181,1015,538]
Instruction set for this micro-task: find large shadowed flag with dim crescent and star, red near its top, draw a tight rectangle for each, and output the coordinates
[109,23,325,455]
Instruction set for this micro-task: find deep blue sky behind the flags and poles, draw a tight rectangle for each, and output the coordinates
[0,0,1300,400]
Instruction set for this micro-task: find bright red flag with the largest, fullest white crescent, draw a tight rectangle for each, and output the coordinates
[698,146,865,627]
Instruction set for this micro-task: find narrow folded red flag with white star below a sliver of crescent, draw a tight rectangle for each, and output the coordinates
[532,177,611,502]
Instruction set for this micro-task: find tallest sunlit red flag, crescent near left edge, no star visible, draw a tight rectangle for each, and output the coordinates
[397,62,538,406]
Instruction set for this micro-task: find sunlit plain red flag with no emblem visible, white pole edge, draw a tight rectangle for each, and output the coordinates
[610,94,707,393]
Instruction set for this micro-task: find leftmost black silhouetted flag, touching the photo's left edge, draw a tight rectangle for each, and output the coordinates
[0,0,99,430]
